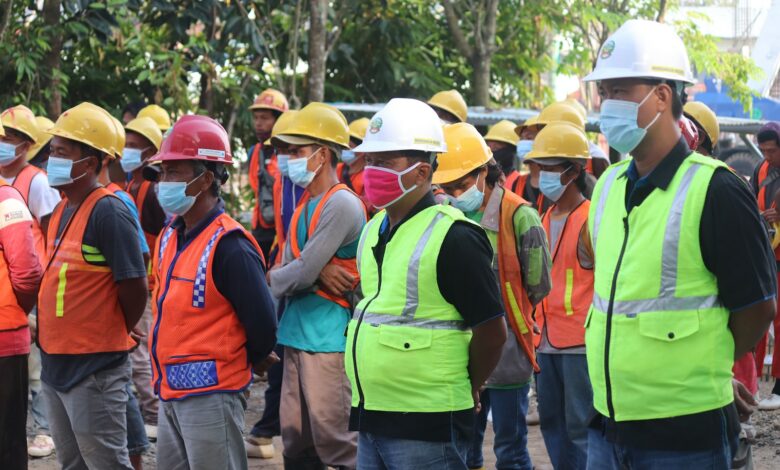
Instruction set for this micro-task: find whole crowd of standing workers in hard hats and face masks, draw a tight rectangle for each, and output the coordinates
[0,16,780,470]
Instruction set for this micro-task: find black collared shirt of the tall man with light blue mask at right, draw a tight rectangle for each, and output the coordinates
[592,139,777,451]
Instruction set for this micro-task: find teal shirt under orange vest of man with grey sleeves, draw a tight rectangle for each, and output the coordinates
[277,196,359,353]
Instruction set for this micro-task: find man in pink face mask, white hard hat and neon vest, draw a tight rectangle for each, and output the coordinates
[346,98,507,469]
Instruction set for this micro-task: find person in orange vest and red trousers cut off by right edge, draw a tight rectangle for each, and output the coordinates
[750,122,780,410]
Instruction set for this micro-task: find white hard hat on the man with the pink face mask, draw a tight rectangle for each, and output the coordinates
[353,98,447,153]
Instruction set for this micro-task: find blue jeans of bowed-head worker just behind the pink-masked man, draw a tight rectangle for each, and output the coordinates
[466,384,533,470]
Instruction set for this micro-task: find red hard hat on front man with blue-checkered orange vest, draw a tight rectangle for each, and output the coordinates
[149,114,233,165]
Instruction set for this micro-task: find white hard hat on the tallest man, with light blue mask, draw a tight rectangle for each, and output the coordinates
[585,20,696,84]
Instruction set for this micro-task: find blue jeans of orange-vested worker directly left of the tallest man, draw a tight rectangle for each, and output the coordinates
[536,353,594,470]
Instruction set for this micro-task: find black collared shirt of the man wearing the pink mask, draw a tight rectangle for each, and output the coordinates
[347,193,504,442]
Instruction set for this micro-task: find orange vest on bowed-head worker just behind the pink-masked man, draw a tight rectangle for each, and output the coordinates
[496,190,539,372]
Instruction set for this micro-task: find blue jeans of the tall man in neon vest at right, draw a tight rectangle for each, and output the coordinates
[588,429,736,470]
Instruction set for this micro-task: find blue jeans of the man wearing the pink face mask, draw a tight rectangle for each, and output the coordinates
[357,430,469,470]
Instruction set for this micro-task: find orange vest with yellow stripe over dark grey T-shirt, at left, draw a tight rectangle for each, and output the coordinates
[38,187,135,354]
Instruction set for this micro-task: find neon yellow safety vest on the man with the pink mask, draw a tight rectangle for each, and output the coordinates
[345,205,474,412]
